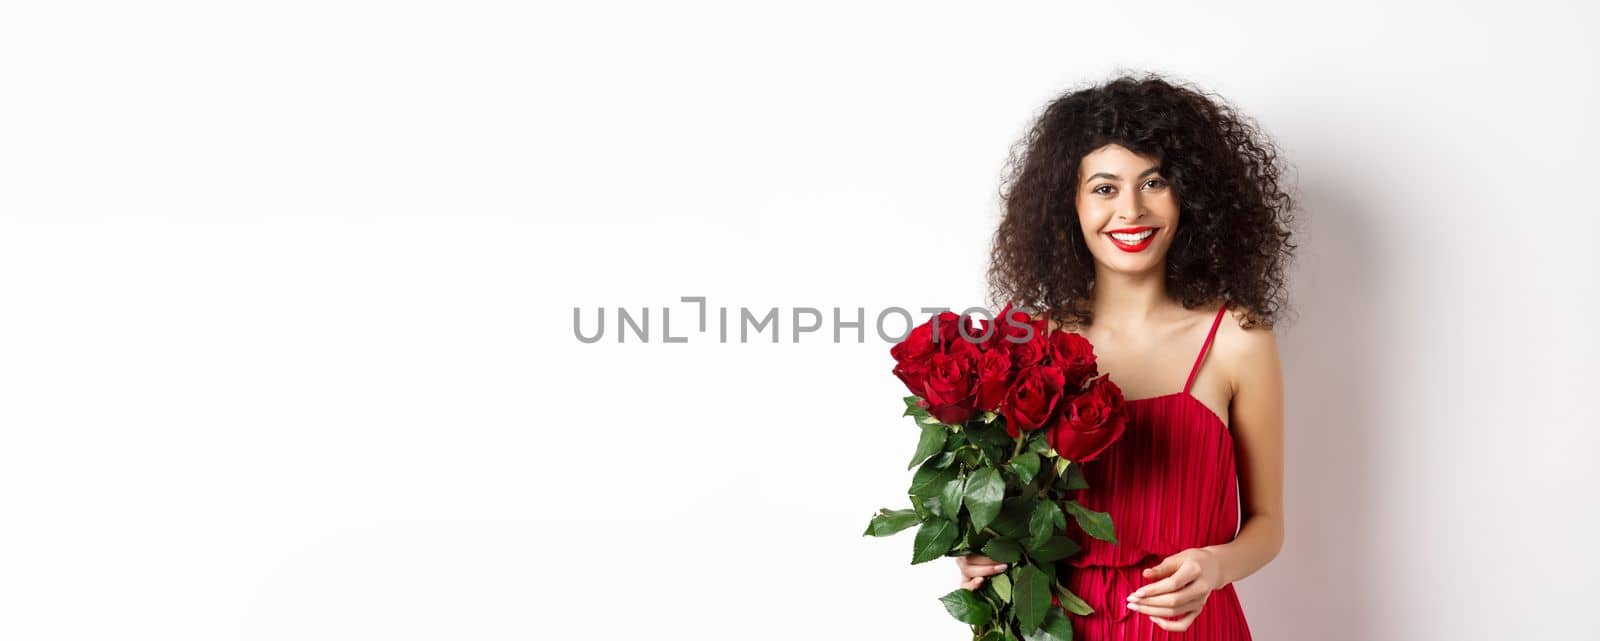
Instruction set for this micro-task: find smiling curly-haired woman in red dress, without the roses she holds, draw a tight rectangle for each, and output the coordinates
[957,75,1294,641]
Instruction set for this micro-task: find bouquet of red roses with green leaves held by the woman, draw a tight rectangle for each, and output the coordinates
[866,305,1126,641]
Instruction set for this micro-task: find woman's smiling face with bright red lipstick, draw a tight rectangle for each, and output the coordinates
[1075,144,1178,273]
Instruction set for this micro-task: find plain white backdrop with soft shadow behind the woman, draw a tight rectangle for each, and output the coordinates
[0,2,1600,641]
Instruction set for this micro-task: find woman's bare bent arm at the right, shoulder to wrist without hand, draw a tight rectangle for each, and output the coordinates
[1203,319,1283,585]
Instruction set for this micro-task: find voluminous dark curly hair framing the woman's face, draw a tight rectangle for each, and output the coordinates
[989,74,1296,328]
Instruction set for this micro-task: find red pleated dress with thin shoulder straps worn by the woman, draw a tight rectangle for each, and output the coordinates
[1067,304,1250,641]
